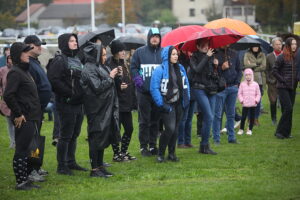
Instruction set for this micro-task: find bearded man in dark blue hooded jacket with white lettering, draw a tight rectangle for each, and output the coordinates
[130,28,162,156]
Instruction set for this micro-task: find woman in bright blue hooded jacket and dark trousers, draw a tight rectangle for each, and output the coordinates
[150,46,190,163]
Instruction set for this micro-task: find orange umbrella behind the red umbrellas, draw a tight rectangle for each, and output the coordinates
[204,18,256,35]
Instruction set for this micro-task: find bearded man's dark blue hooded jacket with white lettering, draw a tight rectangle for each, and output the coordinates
[130,28,162,93]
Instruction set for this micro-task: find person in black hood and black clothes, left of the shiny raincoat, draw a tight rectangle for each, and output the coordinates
[48,33,87,175]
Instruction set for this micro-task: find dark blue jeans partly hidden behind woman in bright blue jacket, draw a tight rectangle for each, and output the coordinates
[178,101,196,145]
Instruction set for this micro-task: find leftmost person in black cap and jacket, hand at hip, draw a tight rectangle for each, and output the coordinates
[4,42,41,190]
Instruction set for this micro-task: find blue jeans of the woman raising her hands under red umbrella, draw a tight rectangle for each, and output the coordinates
[192,89,216,145]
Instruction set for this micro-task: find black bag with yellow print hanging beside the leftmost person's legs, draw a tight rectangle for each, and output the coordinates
[28,123,46,166]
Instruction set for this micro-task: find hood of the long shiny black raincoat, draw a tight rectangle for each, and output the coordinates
[83,42,103,66]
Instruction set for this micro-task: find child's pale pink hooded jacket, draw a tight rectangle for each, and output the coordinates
[238,68,261,107]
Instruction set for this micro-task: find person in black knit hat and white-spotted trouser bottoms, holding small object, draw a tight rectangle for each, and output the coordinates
[106,40,136,162]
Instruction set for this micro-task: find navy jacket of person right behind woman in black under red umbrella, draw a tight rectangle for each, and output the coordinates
[215,49,243,86]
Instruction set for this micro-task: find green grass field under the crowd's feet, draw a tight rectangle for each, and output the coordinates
[0,91,300,200]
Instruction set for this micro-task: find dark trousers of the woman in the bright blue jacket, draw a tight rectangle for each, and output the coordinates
[158,103,183,156]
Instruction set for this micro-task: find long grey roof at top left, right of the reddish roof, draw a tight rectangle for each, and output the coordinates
[39,4,91,19]
